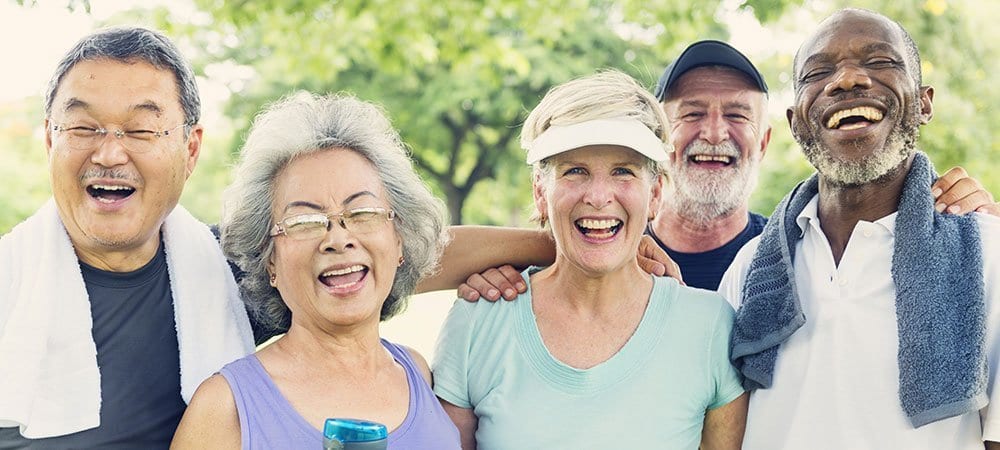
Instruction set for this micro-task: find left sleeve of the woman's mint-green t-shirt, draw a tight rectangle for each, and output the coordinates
[431,299,475,408]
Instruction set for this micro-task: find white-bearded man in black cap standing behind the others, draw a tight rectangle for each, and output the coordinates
[647,41,771,290]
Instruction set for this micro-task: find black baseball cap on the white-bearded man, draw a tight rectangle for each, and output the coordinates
[653,40,767,102]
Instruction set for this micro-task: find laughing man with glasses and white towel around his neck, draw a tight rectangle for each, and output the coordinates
[0,28,254,448]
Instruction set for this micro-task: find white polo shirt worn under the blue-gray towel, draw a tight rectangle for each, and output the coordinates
[719,197,1000,450]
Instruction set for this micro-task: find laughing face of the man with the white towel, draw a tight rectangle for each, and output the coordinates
[45,59,202,271]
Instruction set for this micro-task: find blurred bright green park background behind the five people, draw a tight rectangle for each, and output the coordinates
[0,0,1000,358]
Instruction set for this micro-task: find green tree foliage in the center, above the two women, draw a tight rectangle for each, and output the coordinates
[156,0,740,224]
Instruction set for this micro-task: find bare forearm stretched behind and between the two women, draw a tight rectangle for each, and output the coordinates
[417,225,555,292]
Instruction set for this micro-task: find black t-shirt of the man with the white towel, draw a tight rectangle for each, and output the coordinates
[0,243,185,449]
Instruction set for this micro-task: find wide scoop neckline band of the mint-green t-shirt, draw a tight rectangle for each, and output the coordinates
[514,267,676,394]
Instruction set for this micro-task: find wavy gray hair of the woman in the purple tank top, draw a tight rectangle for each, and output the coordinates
[221,93,447,331]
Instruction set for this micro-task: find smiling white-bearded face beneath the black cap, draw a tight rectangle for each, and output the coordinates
[663,66,771,223]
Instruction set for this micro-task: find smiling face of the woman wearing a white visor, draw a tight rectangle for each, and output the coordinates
[534,145,660,274]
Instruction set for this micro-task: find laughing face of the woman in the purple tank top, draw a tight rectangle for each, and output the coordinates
[268,148,403,327]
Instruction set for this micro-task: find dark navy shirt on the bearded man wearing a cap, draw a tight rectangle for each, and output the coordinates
[646,213,767,291]
